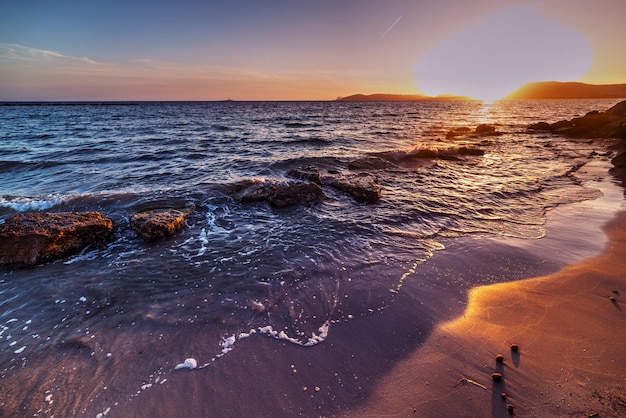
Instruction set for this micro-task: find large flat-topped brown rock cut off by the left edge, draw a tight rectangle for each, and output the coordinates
[0,212,113,265]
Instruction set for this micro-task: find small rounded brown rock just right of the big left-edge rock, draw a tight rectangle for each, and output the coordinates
[130,209,192,241]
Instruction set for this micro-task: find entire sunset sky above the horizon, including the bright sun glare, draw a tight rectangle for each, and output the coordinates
[0,0,626,101]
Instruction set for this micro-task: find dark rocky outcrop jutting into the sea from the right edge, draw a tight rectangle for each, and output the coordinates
[529,101,626,139]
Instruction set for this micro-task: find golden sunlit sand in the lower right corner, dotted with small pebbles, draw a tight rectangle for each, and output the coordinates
[350,166,626,417]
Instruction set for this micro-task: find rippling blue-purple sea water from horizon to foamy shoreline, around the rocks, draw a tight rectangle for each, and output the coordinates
[0,100,618,416]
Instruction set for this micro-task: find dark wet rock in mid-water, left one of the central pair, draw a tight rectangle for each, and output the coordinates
[239,180,325,208]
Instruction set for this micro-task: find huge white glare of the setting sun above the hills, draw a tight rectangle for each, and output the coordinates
[415,6,592,102]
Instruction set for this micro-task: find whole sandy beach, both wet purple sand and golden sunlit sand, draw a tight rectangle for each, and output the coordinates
[108,164,626,417]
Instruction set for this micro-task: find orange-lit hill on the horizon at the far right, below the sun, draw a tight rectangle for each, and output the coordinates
[504,81,626,100]
